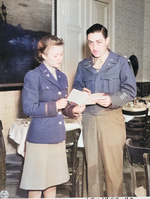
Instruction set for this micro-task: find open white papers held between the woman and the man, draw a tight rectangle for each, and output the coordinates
[67,89,103,105]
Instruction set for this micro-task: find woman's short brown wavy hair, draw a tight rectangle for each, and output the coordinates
[35,34,64,63]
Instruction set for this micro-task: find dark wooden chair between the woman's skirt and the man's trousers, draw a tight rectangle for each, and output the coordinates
[57,128,81,197]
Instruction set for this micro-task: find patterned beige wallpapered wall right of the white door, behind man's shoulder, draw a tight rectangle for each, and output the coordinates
[115,0,145,80]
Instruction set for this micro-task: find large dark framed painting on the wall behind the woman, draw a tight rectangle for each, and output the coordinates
[0,0,57,91]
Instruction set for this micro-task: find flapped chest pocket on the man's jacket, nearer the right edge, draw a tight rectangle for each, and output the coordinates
[101,73,120,93]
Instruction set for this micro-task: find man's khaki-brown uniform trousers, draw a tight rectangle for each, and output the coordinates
[82,108,126,197]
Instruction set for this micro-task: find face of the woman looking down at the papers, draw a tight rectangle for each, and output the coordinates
[42,45,63,68]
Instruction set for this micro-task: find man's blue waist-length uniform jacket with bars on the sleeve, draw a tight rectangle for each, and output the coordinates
[73,51,137,115]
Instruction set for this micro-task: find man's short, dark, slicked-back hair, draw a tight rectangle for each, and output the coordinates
[86,23,108,39]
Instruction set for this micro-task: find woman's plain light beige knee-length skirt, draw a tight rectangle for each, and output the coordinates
[20,141,69,190]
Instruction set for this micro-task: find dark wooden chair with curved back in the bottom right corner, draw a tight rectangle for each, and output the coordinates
[126,138,150,197]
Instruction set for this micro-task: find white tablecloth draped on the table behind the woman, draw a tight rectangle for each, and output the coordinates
[9,118,84,157]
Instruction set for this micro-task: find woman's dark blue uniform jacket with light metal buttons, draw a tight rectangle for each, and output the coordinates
[22,63,72,144]
